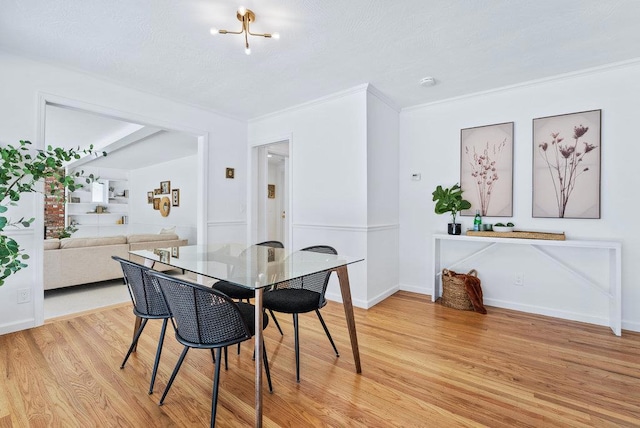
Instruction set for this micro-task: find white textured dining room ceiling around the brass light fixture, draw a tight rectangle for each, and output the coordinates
[0,0,640,119]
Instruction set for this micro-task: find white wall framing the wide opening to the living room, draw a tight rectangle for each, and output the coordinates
[0,53,247,334]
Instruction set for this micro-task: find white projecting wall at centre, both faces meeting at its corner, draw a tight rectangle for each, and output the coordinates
[249,85,399,308]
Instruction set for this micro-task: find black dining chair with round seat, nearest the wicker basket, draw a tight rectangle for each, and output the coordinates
[262,245,340,382]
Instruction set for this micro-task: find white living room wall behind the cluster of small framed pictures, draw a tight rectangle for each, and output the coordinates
[129,156,198,244]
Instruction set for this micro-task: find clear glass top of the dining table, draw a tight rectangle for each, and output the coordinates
[129,244,364,289]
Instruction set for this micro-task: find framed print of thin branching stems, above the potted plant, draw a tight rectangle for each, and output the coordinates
[460,122,514,217]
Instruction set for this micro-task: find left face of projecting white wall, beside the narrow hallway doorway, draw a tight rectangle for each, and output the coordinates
[248,87,368,307]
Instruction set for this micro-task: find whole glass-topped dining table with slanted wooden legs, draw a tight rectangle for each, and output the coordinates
[129,243,364,427]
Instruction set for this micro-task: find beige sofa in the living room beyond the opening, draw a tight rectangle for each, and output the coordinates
[44,234,187,290]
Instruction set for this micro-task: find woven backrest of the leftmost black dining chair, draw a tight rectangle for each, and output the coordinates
[111,256,170,317]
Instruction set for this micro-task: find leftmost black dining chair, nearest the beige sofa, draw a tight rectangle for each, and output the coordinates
[111,256,171,394]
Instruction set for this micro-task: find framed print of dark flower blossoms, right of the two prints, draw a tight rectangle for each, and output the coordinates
[532,110,602,219]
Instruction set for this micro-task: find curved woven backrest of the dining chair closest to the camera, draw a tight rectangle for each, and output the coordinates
[149,271,252,347]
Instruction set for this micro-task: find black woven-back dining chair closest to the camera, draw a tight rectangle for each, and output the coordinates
[149,272,273,427]
